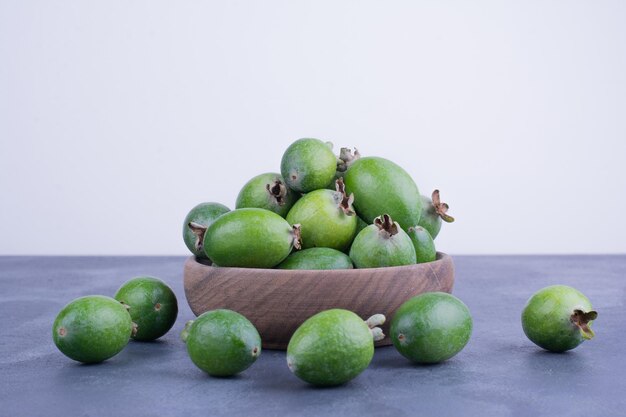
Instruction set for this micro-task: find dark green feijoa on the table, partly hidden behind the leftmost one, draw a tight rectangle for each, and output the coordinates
[115,276,178,341]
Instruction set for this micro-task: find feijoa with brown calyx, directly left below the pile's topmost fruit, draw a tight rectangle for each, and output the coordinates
[235,172,300,217]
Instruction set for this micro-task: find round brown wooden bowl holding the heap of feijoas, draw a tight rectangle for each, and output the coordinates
[184,252,454,349]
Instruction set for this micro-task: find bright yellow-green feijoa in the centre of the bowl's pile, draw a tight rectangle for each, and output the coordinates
[287,190,357,251]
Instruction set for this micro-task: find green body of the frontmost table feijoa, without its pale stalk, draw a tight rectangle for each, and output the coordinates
[287,309,374,386]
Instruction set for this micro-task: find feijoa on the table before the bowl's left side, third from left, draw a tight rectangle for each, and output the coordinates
[181,309,261,376]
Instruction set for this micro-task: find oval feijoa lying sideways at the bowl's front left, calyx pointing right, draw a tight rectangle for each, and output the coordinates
[204,208,300,268]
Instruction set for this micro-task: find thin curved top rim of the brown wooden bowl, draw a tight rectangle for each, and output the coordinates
[187,252,452,275]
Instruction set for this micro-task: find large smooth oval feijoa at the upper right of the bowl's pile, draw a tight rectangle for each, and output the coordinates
[344,157,422,231]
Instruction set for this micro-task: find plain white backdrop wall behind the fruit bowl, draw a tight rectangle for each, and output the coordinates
[0,0,626,254]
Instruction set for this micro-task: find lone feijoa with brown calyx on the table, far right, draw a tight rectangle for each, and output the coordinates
[522,285,598,352]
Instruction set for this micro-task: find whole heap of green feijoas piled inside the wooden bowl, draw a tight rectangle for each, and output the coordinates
[183,139,454,269]
